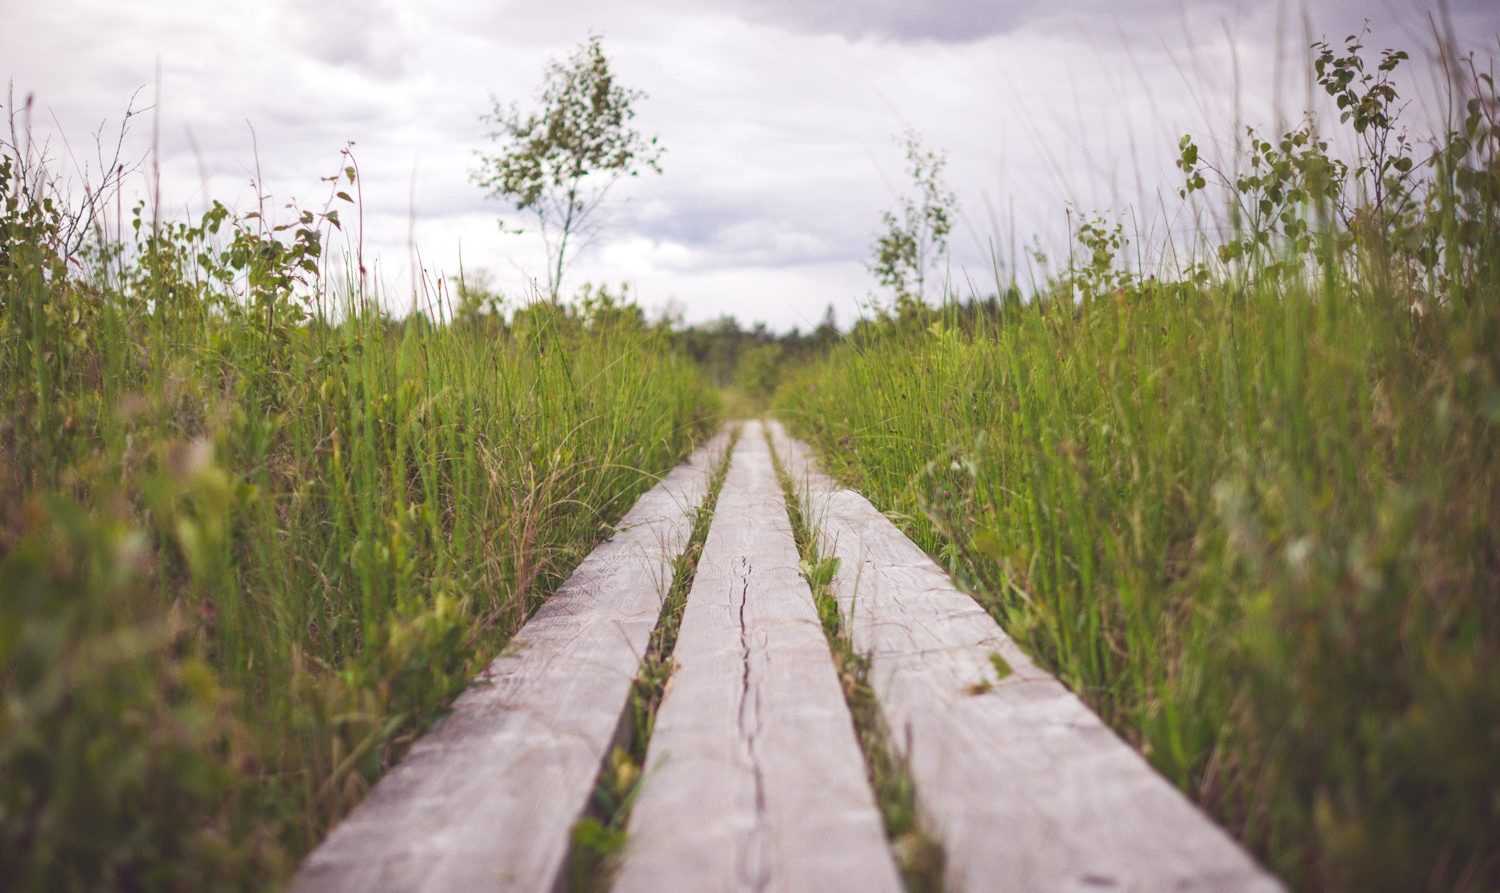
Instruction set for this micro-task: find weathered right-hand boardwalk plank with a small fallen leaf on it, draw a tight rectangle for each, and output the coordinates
[771,423,1281,893]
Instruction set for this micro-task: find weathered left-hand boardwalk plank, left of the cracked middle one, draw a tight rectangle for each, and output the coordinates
[293,434,728,891]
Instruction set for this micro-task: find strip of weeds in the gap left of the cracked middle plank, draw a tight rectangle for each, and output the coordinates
[567,428,740,891]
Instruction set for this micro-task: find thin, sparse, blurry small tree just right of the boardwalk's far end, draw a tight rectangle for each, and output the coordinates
[870,131,959,305]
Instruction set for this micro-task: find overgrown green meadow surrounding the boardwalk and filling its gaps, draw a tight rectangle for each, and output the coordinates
[0,27,1500,891]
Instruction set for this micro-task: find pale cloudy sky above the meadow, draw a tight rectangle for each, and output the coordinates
[0,0,1500,330]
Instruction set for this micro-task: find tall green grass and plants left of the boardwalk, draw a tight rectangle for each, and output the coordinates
[0,138,716,890]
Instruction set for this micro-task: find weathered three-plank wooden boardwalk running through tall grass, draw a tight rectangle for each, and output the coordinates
[294,422,1281,893]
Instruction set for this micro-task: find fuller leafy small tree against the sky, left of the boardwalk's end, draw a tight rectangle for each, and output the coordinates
[474,36,662,300]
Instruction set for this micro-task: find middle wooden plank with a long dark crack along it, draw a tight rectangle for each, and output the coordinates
[615,423,900,893]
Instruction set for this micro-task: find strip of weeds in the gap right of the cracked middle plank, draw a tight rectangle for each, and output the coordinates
[765,428,947,893]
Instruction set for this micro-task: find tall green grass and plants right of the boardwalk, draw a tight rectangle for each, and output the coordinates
[777,38,1500,890]
